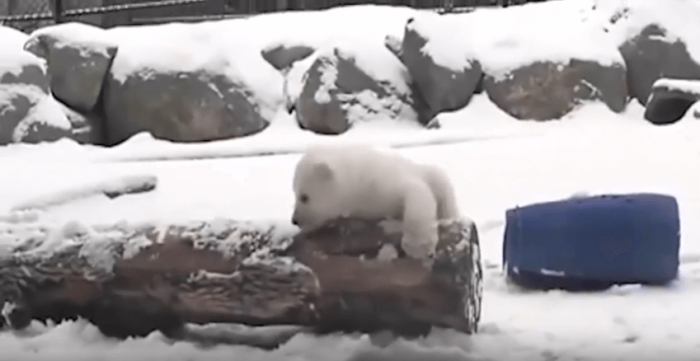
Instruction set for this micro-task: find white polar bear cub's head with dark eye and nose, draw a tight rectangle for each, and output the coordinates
[292,154,343,231]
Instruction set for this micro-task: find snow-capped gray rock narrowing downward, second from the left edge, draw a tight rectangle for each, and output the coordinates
[25,22,117,112]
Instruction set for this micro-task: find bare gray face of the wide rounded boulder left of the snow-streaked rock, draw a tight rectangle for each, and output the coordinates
[104,70,269,145]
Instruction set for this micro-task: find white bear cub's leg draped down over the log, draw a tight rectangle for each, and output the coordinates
[401,181,438,259]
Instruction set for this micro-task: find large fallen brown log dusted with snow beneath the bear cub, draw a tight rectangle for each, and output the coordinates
[0,219,482,337]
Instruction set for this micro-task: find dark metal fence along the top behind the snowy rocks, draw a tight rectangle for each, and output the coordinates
[0,0,545,32]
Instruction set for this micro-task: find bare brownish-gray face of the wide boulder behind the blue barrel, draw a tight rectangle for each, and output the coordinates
[483,59,627,120]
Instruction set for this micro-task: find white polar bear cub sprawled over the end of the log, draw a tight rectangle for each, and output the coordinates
[292,144,460,259]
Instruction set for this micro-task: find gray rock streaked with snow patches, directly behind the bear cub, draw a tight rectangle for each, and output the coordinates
[294,47,425,134]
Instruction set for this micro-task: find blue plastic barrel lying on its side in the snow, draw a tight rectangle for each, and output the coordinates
[503,193,680,290]
